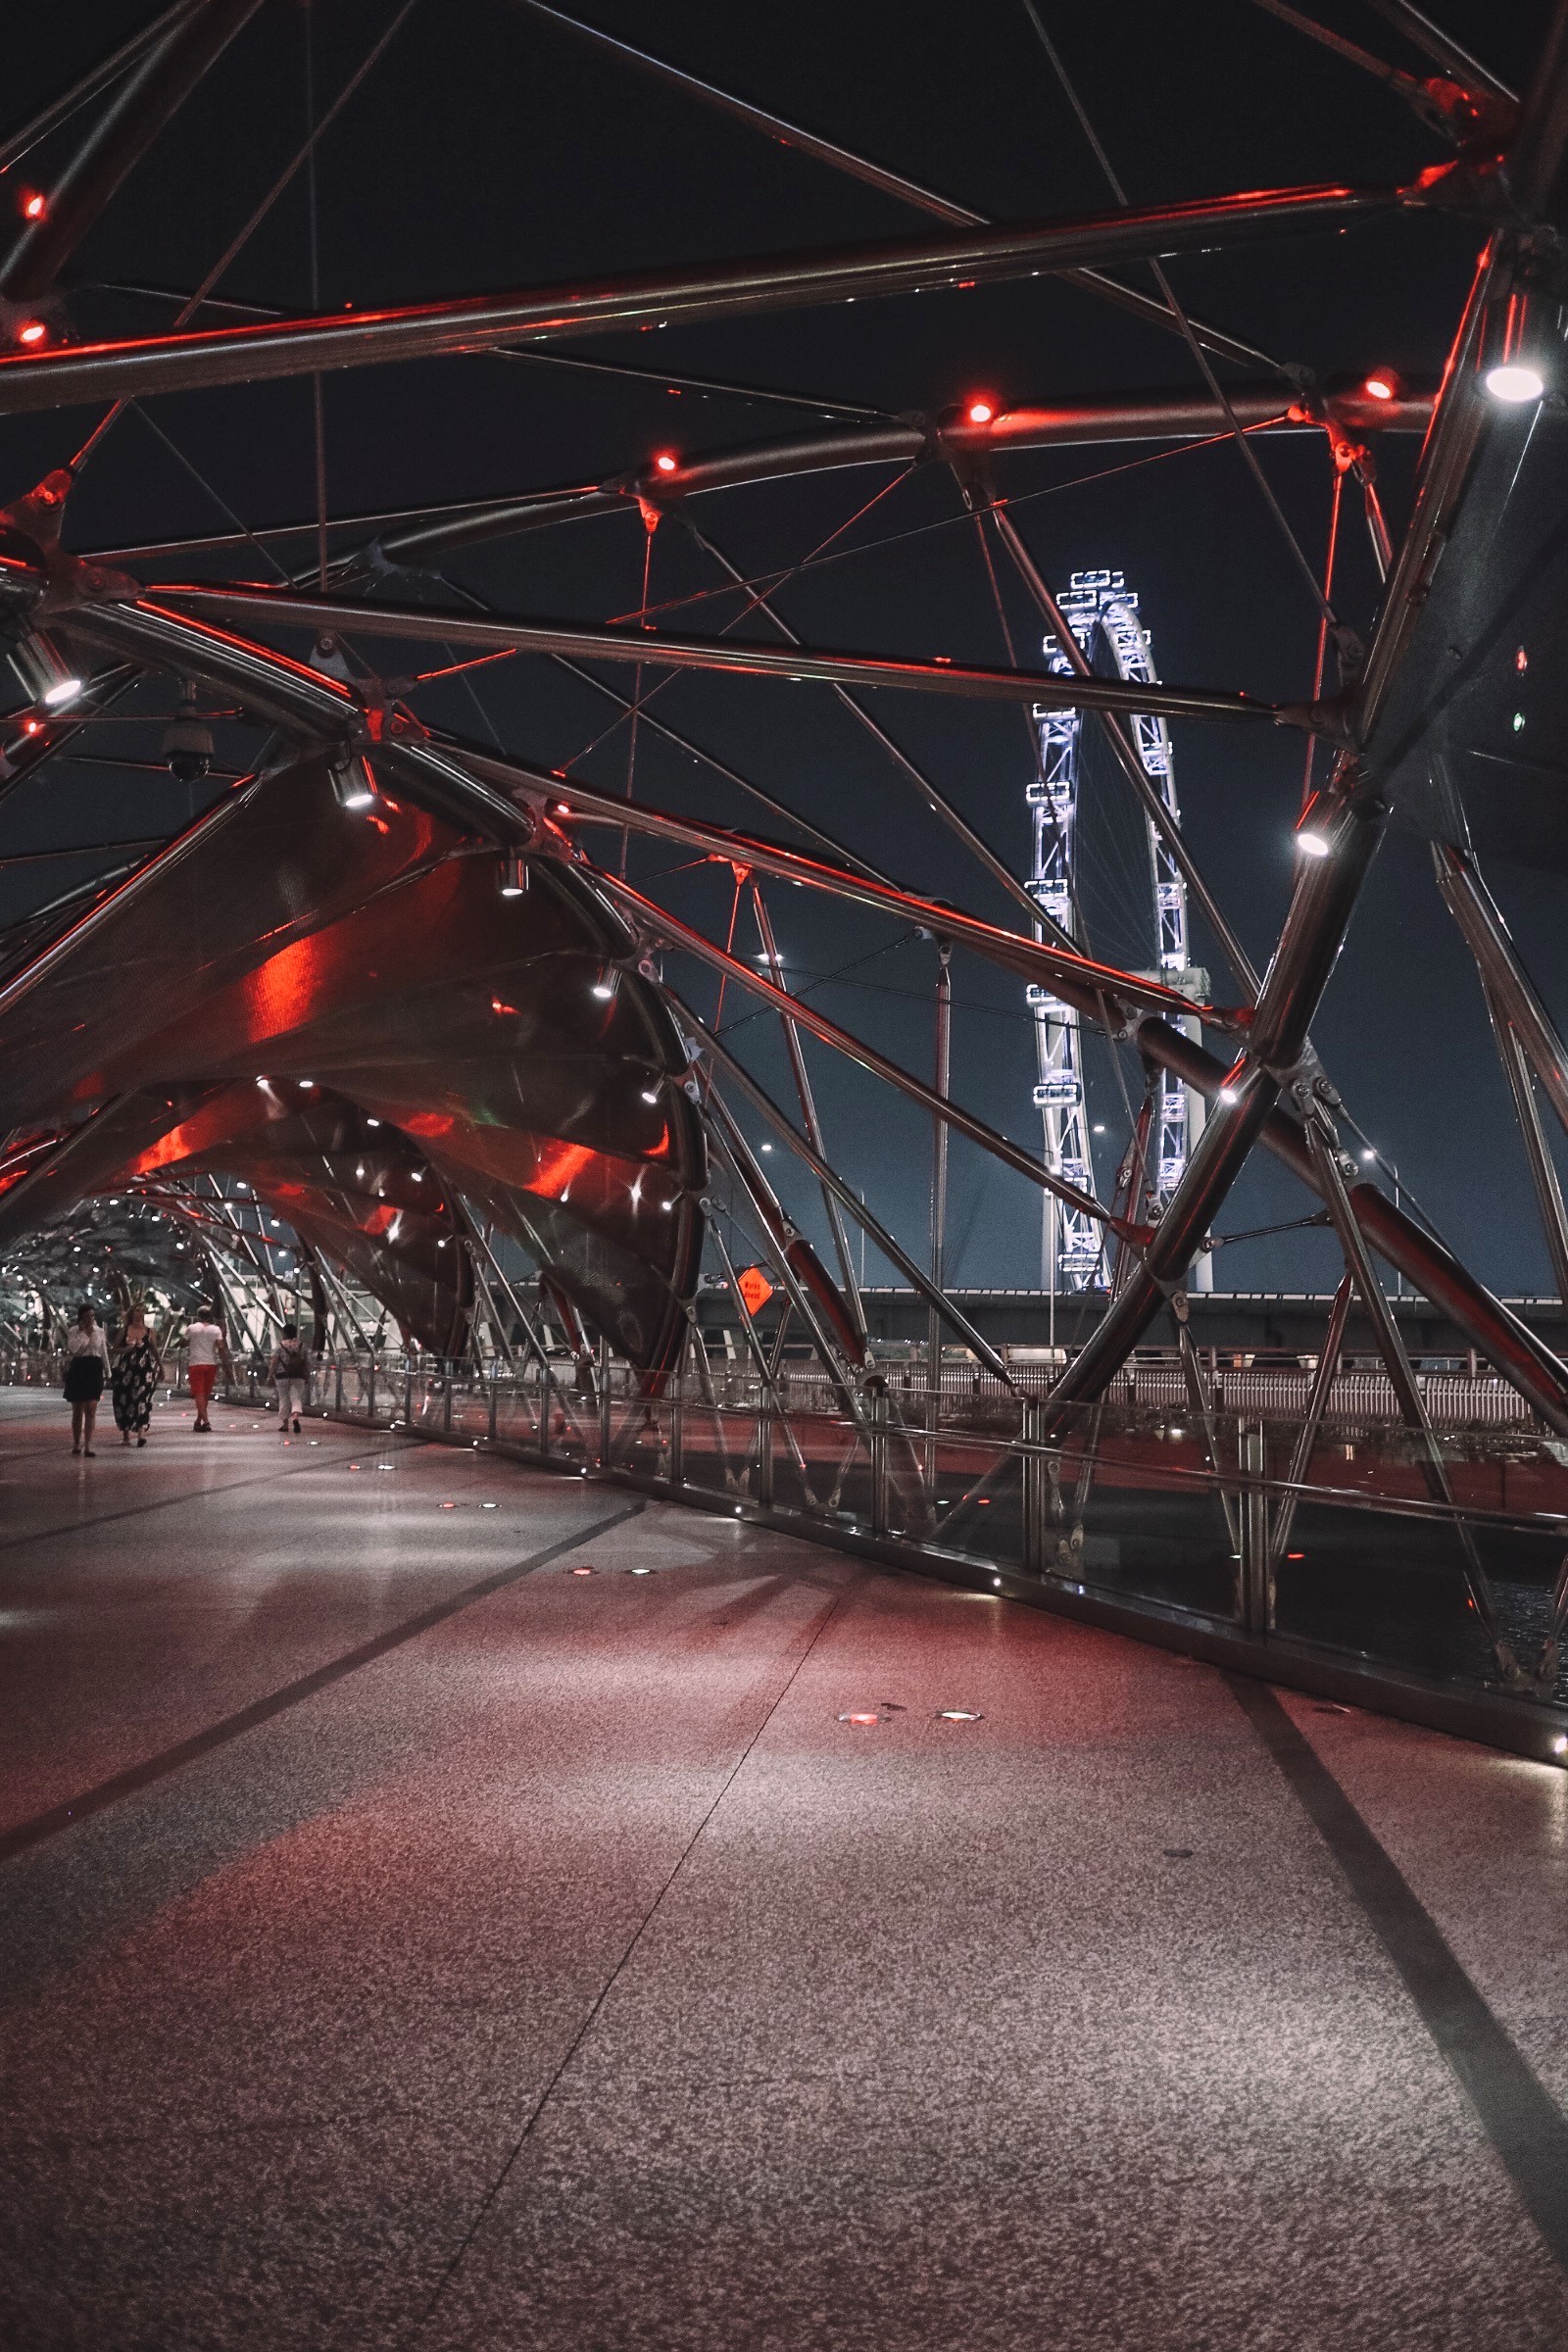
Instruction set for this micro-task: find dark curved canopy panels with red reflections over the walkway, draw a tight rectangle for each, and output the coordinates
[0,758,706,1374]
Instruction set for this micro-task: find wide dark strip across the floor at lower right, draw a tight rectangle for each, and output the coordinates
[1222,1672,1568,2272]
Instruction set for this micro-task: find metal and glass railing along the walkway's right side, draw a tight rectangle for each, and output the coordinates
[0,1352,1568,1759]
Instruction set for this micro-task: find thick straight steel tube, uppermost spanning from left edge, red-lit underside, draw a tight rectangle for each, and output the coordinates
[0,183,1427,416]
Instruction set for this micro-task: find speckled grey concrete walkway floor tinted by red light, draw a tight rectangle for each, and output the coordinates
[0,1390,1568,2352]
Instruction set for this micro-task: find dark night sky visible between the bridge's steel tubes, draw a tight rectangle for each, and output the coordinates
[0,0,1568,1292]
